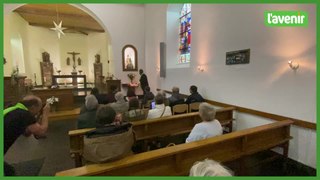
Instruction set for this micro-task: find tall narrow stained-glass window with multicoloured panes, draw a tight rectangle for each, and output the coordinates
[178,4,191,64]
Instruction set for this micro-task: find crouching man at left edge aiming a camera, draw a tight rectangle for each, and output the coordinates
[3,95,50,176]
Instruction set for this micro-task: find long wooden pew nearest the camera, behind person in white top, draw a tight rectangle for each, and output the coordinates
[56,120,293,176]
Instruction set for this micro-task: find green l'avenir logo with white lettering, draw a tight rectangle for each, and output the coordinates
[264,11,308,27]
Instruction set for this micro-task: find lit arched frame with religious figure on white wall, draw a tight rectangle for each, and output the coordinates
[122,45,138,71]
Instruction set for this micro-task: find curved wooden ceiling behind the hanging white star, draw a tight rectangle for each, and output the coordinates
[14,4,105,35]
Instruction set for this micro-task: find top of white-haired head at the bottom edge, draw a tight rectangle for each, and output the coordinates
[189,159,233,176]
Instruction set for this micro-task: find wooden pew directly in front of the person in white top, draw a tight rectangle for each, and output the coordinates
[69,107,234,167]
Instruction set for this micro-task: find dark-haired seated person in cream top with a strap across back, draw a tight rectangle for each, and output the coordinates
[147,93,172,119]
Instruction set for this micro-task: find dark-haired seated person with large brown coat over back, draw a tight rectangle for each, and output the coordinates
[83,105,135,163]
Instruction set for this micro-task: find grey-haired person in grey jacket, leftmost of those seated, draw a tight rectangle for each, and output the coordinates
[77,94,99,129]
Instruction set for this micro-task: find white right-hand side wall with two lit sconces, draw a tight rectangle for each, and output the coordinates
[146,4,316,167]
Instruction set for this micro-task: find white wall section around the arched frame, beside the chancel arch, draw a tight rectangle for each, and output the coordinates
[82,4,146,83]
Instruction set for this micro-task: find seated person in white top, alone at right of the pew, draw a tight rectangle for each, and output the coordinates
[186,103,222,143]
